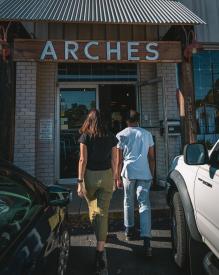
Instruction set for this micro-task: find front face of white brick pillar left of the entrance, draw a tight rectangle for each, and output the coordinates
[14,62,37,175]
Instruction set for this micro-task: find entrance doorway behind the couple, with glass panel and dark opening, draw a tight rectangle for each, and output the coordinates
[57,84,137,184]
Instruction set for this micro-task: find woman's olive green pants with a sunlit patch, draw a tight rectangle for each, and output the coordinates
[84,169,113,241]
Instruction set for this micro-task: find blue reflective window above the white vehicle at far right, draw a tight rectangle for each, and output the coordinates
[193,51,219,148]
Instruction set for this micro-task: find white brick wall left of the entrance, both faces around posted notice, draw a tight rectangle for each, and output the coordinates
[14,62,57,184]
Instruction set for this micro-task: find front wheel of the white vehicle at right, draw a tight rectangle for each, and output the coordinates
[171,192,187,268]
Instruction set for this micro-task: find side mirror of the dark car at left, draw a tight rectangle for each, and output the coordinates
[47,185,70,207]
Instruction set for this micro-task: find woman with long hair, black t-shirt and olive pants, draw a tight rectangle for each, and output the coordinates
[78,109,118,272]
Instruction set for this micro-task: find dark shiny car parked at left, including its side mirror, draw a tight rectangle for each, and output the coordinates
[0,161,70,275]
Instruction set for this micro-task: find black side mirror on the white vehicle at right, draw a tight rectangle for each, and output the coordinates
[183,143,209,165]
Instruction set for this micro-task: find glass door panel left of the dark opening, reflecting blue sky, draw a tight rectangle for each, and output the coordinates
[59,87,98,183]
